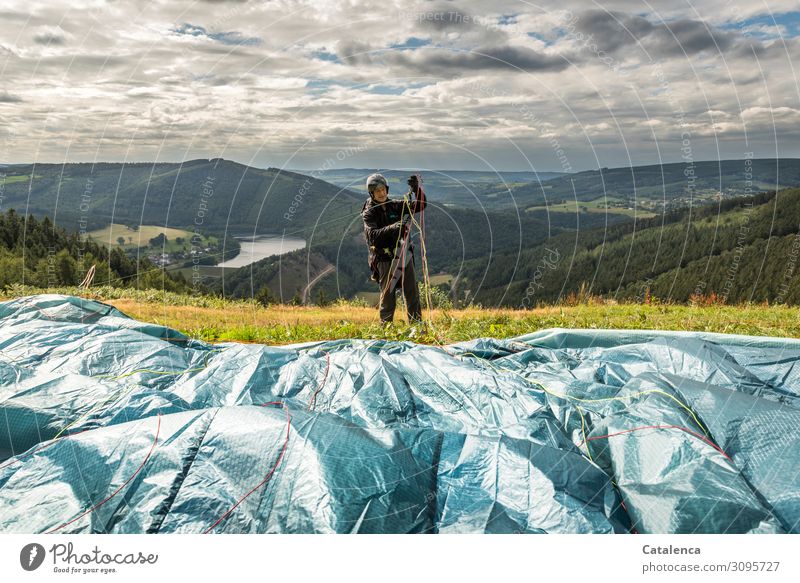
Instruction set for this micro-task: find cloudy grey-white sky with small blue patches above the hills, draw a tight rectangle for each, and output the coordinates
[0,0,800,171]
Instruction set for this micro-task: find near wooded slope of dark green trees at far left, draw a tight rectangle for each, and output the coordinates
[0,209,190,292]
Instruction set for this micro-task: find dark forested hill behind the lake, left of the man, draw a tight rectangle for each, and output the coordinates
[3,158,363,237]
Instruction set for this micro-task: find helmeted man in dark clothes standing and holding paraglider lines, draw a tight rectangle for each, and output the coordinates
[361,174,427,323]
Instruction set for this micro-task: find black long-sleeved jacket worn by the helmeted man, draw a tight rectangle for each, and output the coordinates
[361,190,427,279]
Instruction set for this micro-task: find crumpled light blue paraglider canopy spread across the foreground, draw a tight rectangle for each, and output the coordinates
[0,295,800,533]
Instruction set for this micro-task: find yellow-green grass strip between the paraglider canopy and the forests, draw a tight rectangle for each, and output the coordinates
[2,287,800,344]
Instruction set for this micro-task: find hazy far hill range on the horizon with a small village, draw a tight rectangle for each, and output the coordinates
[298,158,800,213]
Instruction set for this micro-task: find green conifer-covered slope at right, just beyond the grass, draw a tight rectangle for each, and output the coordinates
[462,189,800,306]
